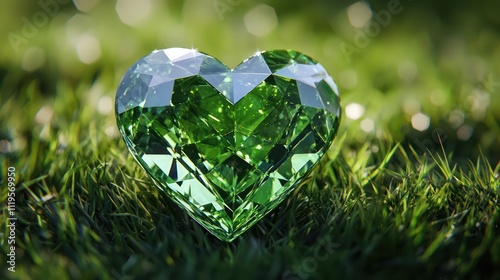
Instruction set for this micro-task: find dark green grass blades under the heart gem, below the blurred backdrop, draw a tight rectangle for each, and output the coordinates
[1,119,500,279]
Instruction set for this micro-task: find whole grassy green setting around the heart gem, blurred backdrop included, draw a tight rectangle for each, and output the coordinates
[0,0,500,279]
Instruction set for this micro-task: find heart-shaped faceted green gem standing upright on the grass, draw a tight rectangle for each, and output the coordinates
[116,48,341,241]
